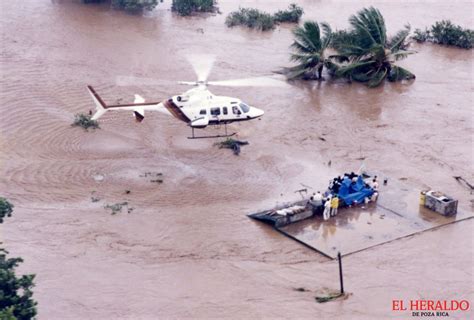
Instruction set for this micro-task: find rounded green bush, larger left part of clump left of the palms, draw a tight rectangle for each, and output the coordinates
[225,8,275,31]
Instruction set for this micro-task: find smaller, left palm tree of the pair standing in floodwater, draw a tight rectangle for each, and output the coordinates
[282,21,335,80]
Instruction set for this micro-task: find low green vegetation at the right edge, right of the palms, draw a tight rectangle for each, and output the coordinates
[413,20,474,49]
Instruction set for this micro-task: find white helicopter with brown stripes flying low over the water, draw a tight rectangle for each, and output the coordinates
[87,55,285,139]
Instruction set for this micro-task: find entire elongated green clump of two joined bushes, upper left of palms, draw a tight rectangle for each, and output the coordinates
[225,4,303,31]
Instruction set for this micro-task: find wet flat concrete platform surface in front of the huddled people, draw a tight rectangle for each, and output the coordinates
[250,181,474,259]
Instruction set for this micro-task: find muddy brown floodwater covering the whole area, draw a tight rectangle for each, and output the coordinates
[0,0,474,319]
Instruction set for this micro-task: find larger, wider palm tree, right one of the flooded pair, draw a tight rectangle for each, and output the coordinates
[332,7,415,87]
